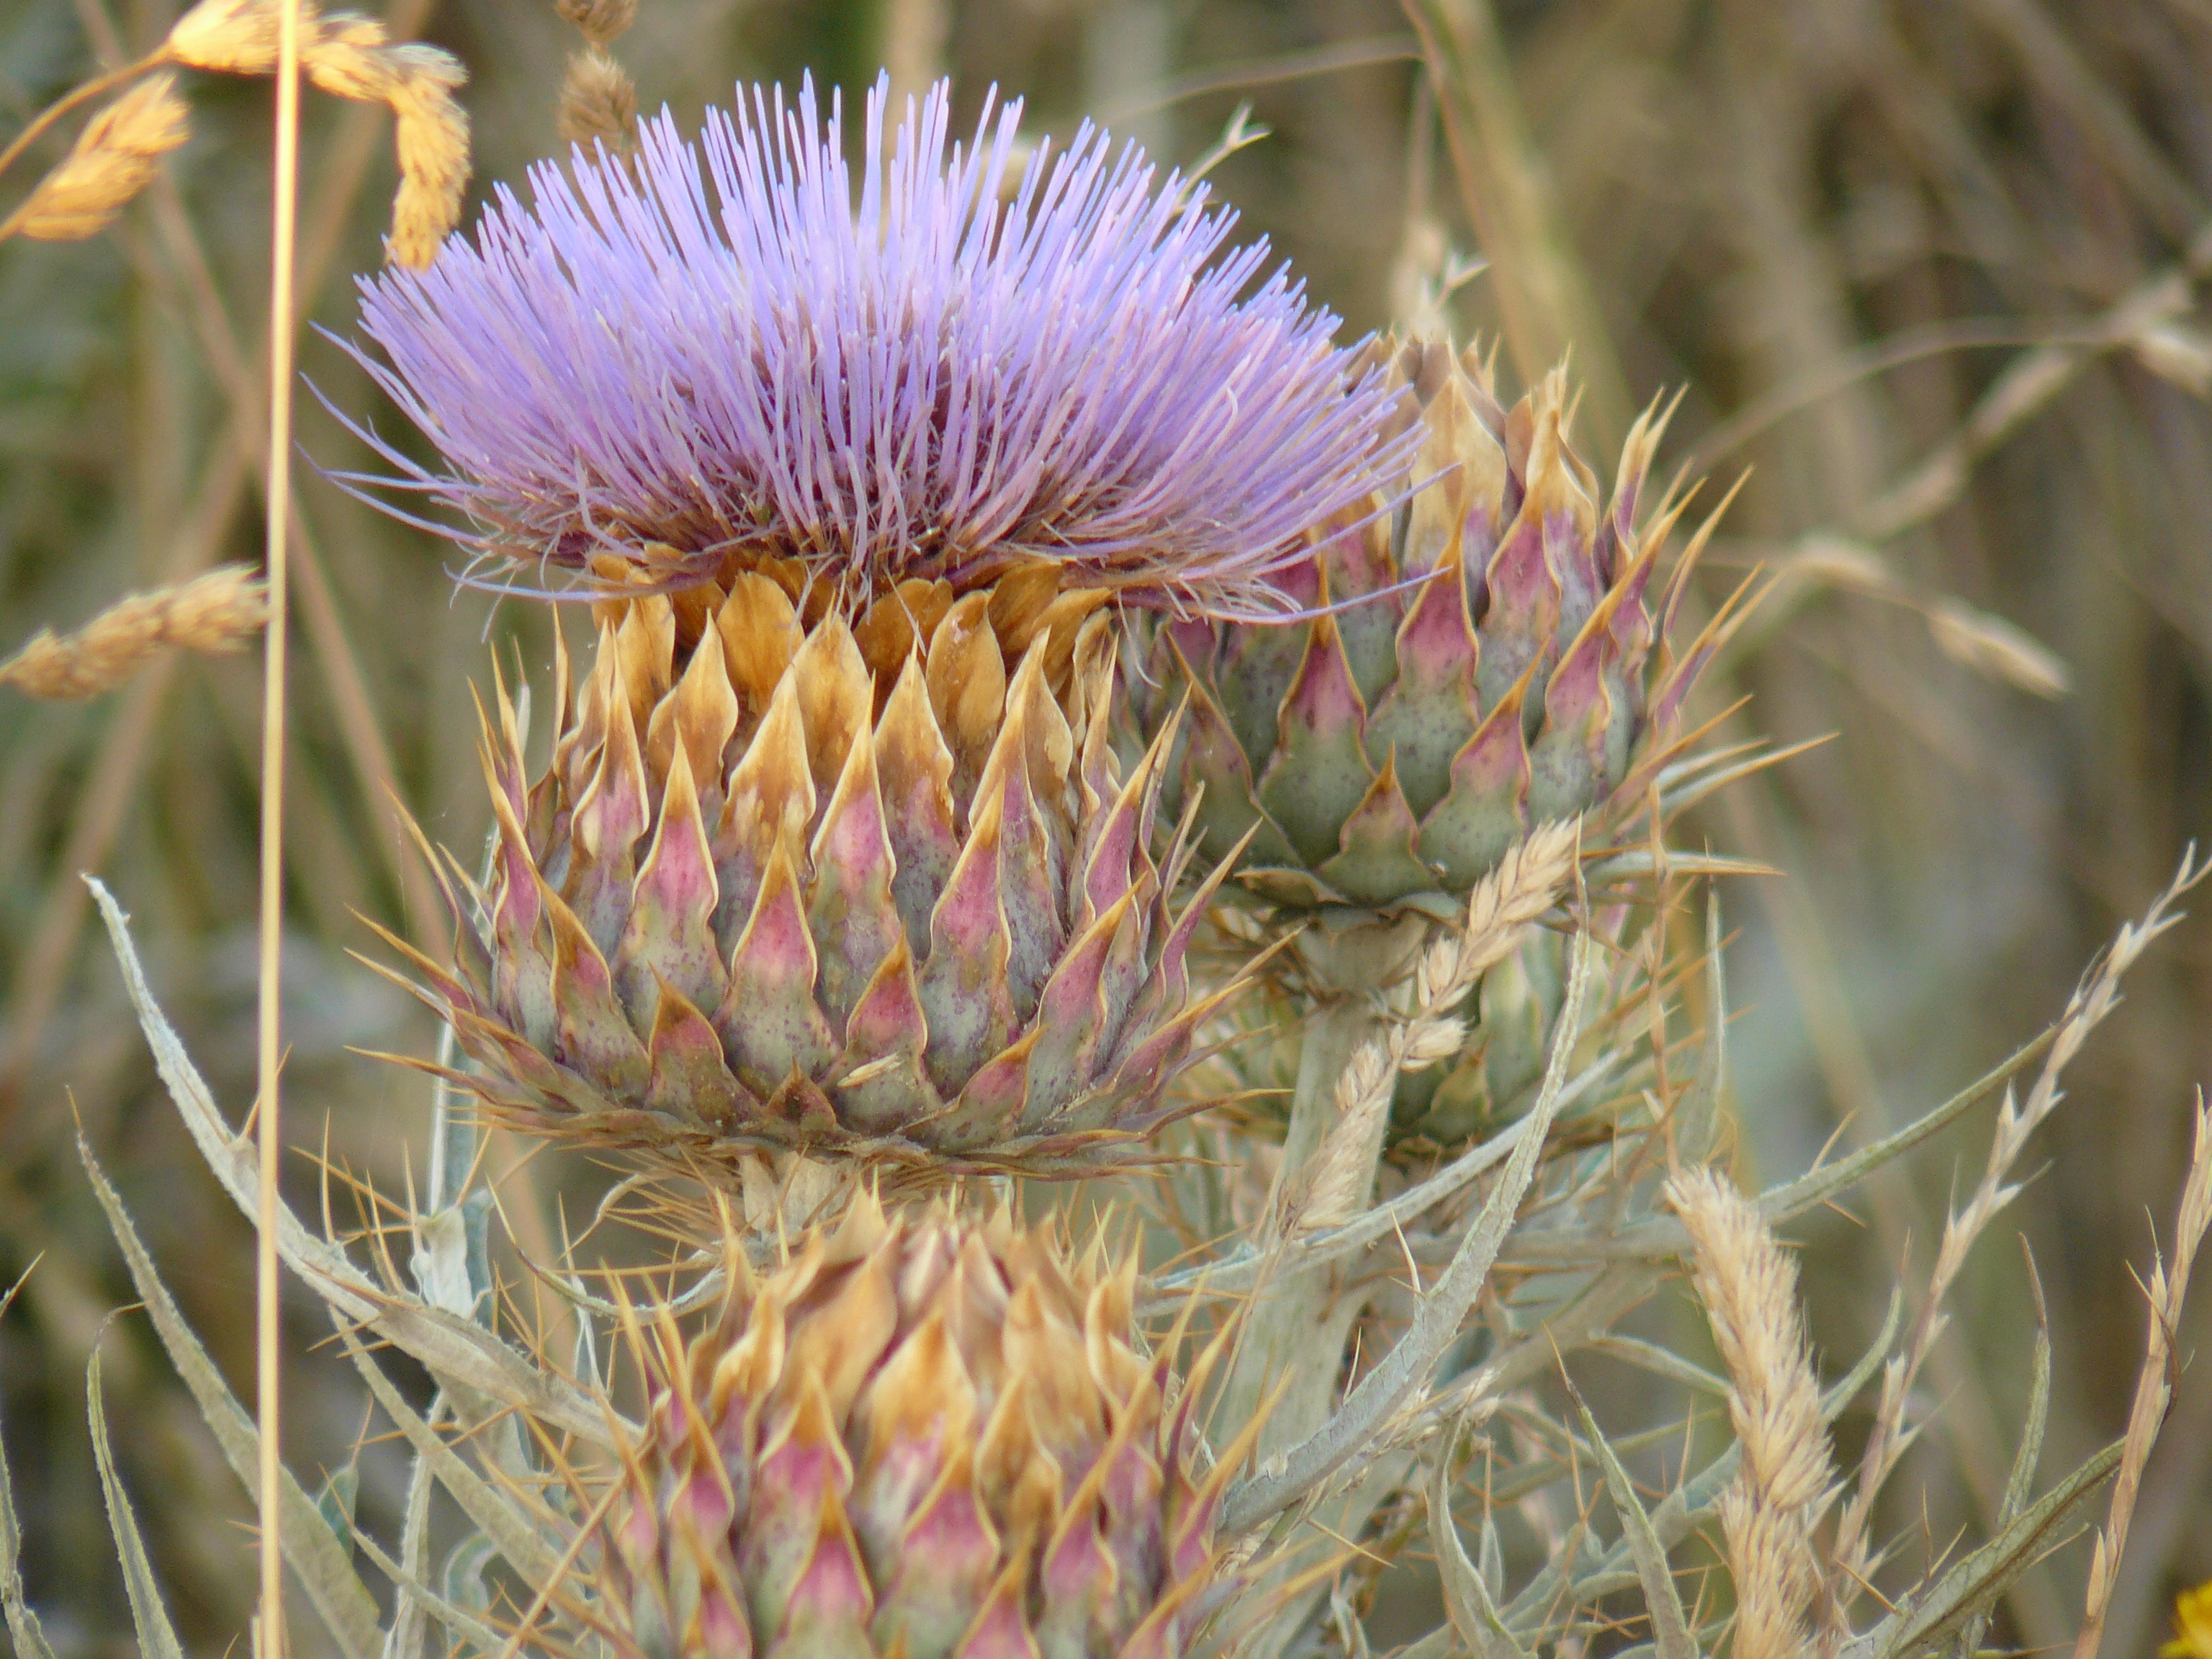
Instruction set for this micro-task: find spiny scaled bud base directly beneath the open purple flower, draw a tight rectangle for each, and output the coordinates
[394,564,1226,1186]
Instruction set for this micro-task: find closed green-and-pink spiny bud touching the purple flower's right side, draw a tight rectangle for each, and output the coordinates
[1133,343,1739,918]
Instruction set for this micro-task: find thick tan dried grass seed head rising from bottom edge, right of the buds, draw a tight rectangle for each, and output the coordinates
[1665,1170,1830,1659]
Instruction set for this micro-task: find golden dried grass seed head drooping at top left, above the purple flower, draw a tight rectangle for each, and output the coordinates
[161,0,469,268]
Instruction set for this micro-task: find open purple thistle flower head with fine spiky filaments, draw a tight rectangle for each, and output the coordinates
[347,82,1413,615]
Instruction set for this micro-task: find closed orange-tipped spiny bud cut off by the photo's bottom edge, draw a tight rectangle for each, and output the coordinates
[600,1199,1246,1659]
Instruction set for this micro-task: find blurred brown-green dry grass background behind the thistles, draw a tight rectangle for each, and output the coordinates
[0,0,2212,1655]
